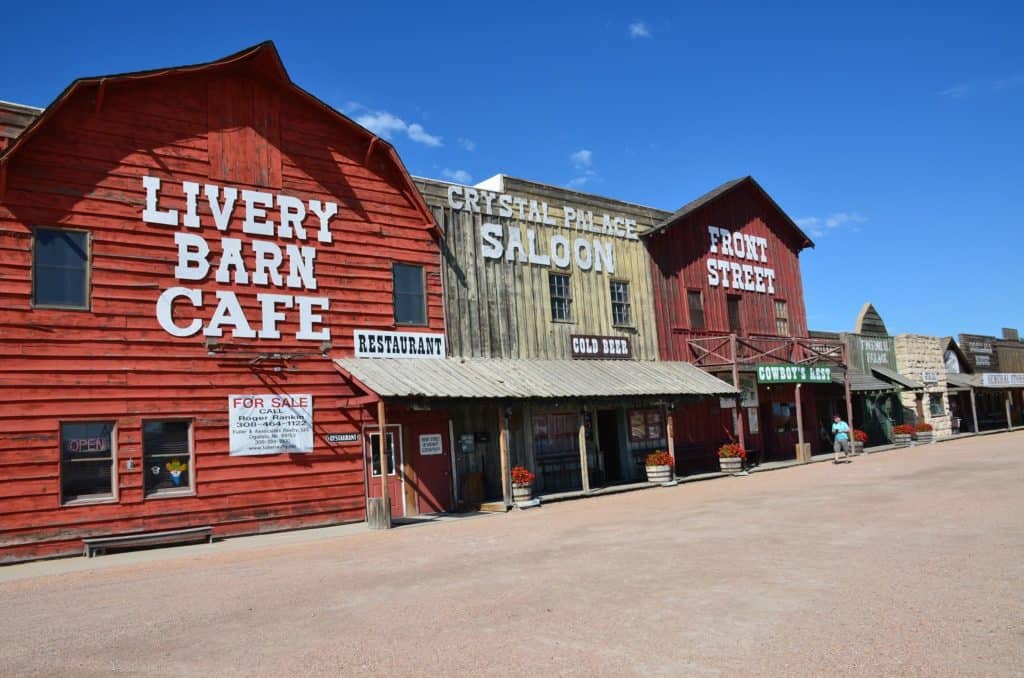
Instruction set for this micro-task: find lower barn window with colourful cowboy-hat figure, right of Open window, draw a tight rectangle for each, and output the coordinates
[142,421,193,495]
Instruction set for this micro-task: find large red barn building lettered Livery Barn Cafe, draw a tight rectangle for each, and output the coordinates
[0,43,451,561]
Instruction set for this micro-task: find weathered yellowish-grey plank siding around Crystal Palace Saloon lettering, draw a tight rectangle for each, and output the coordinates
[417,177,668,359]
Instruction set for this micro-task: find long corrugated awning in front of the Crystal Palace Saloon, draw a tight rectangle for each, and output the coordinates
[335,357,737,398]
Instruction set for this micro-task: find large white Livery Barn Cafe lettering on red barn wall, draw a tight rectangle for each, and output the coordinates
[142,176,338,341]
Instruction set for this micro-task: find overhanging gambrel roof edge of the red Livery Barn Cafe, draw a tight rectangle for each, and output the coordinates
[0,40,440,237]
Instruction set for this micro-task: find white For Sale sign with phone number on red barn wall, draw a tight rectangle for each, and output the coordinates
[227,393,313,457]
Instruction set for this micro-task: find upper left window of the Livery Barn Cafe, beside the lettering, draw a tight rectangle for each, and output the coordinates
[32,228,89,308]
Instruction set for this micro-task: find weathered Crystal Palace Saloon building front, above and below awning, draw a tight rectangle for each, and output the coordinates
[407,175,729,500]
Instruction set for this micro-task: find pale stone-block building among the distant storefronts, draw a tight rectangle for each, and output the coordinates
[893,334,952,438]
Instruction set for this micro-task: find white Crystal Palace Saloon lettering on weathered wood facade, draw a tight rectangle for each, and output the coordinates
[447,185,639,273]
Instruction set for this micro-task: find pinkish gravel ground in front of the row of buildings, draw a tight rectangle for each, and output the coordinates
[0,433,1024,676]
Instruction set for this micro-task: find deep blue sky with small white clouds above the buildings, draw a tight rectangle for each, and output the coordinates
[0,2,1024,335]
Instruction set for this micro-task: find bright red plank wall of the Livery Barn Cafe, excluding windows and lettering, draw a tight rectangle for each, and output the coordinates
[0,63,443,561]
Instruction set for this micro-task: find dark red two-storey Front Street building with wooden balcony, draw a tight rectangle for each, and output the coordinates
[644,176,842,472]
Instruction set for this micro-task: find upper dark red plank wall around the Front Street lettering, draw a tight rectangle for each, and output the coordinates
[648,184,807,361]
